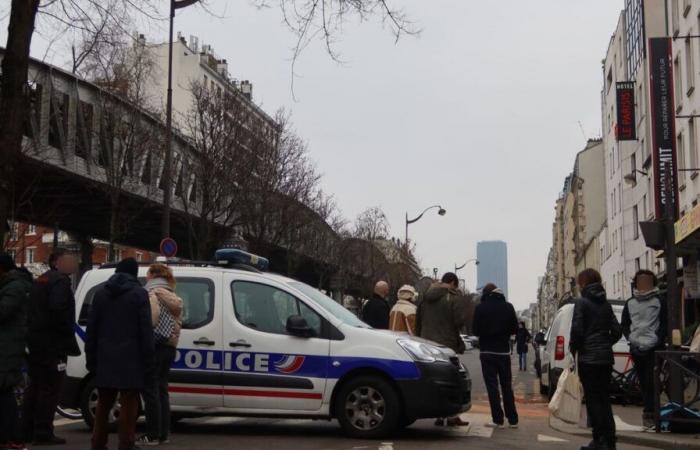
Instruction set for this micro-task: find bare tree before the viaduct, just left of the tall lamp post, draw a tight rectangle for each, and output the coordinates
[80,32,162,260]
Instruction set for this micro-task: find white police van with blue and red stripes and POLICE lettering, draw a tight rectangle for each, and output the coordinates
[62,249,471,438]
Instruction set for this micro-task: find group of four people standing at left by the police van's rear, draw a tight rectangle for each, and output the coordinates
[0,249,183,450]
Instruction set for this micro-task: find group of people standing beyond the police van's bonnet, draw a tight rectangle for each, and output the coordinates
[361,272,530,428]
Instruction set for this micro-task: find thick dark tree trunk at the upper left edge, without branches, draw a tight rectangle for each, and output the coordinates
[0,0,39,242]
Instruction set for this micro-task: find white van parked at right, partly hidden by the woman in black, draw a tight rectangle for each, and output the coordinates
[540,300,632,397]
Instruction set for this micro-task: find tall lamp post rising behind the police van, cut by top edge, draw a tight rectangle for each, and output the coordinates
[161,0,199,239]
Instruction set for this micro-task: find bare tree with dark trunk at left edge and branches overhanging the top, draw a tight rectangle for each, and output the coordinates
[0,0,415,241]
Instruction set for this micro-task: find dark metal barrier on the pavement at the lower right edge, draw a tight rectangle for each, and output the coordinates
[654,351,700,433]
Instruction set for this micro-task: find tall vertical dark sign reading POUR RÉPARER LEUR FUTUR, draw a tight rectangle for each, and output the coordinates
[648,38,679,221]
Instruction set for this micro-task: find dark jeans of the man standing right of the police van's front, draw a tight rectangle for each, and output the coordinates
[479,353,518,425]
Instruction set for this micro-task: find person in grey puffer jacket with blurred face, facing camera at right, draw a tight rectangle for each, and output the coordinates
[622,270,667,429]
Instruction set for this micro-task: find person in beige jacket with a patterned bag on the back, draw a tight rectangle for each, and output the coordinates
[138,264,183,446]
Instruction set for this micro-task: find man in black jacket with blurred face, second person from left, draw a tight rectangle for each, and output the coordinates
[22,249,80,445]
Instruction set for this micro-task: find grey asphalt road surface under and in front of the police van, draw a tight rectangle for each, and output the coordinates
[41,351,656,450]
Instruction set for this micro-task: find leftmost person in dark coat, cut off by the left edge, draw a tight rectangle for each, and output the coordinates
[0,253,32,448]
